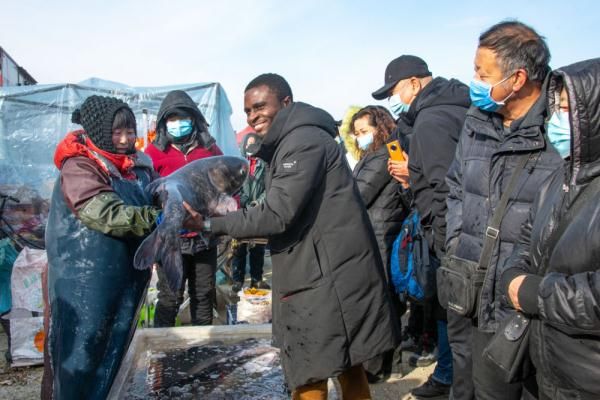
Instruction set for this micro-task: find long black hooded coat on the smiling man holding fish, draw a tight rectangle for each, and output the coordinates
[212,103,398,389]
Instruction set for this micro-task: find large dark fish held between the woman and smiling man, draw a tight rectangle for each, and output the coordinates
[133,156,248,291]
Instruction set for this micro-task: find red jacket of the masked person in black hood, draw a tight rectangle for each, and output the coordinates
[146,143,223,176]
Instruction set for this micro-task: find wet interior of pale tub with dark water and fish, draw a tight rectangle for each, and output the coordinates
[125,339,289,400]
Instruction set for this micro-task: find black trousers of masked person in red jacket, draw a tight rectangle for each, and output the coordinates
[154,248,217,327]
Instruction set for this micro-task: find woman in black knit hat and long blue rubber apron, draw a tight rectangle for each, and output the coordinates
[42,96,159,400]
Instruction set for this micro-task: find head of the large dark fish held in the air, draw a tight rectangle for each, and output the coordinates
[208,156,248,196]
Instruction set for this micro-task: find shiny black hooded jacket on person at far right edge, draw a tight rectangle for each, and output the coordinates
[503,59,600,399]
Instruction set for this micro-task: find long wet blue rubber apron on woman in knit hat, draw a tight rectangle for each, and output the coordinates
[46,163,150,400]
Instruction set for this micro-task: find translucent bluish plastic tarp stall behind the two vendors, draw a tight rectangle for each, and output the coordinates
[0,78,239,247]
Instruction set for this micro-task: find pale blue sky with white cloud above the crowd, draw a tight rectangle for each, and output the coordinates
[0,0,600,130]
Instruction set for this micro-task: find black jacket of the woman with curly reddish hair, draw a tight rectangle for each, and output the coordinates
[353,146,410,274]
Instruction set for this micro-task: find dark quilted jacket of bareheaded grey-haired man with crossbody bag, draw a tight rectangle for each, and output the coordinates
[446,83,562,332]
